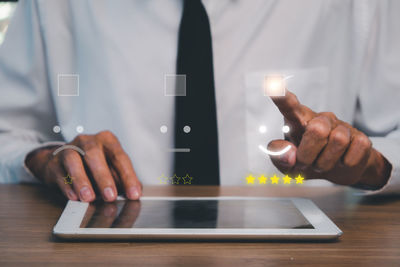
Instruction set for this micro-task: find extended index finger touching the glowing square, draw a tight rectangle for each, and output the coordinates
[271,90,315,127]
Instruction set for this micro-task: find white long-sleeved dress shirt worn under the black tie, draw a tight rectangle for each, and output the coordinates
[0,0,400,192]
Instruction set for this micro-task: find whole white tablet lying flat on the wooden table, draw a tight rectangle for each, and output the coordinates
[53,197,342,240]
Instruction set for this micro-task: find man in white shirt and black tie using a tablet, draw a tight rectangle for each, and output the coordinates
[0,0,400,201]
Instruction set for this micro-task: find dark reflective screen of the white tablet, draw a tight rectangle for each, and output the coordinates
[80,199,314,229]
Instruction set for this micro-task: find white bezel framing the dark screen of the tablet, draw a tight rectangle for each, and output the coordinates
[53,196,342,240]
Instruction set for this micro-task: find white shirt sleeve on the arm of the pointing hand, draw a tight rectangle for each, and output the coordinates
[355,1,400,194]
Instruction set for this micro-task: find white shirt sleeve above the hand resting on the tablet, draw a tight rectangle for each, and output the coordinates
[0,0,59,183]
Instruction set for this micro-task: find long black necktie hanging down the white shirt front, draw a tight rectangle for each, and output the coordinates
[175,0,219,185]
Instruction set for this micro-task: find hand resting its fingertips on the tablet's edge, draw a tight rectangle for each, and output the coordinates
[26,131,142,202]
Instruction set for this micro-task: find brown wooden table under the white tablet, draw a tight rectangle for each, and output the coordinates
[0,185,400,266]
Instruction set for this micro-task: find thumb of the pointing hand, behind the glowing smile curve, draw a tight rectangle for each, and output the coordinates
[268,140,297,173]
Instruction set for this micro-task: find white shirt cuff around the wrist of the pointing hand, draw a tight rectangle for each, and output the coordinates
[358,137,400,195]
